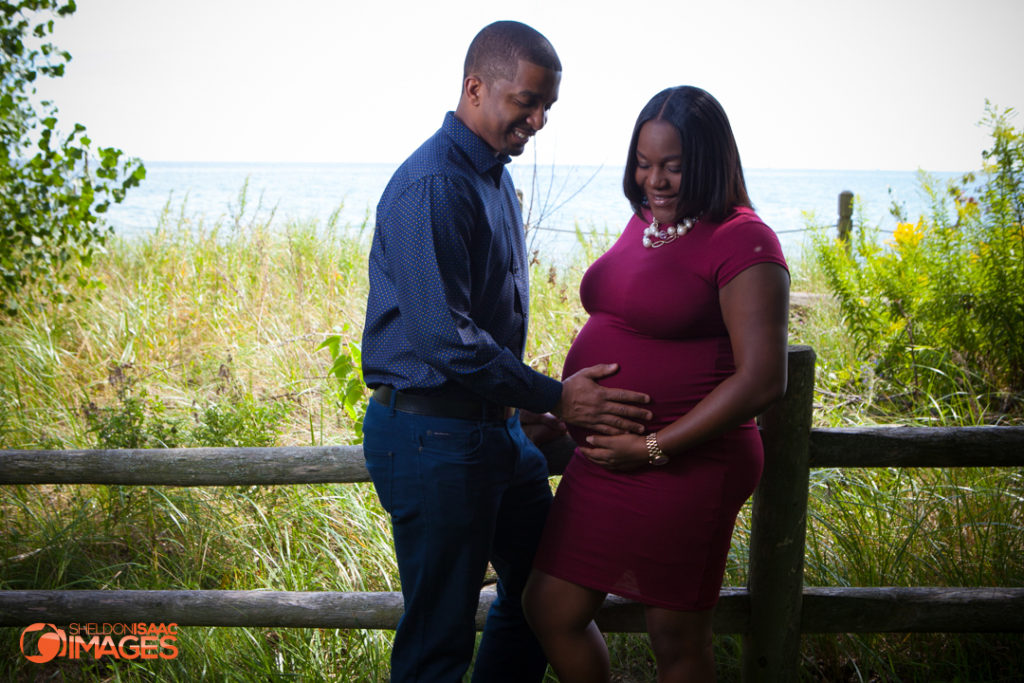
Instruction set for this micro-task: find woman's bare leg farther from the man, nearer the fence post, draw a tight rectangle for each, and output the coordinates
[644,605,715,683]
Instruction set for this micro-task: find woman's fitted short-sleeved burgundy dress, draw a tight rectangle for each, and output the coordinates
[535,209,785,610]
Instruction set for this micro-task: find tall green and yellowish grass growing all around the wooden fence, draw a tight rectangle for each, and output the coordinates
[0,200,1024,681]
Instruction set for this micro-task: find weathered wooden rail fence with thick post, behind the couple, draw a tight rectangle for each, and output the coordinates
[0,346,1024,681]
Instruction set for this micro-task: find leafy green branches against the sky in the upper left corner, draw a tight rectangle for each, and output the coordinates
[0,0,145,313]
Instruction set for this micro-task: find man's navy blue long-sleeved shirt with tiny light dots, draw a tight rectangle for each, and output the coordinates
[362,112,561,413]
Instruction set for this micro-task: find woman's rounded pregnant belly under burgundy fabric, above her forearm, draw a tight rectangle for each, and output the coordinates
[562,315,733,443]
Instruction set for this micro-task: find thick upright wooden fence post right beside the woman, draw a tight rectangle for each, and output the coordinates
[742,346,816,683]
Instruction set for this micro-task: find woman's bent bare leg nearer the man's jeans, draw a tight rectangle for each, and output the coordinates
[522,569,610,683]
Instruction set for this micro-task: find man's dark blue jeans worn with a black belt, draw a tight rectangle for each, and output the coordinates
[362,399,552,683]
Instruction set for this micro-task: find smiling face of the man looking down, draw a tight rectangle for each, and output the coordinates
[464,59,562,157]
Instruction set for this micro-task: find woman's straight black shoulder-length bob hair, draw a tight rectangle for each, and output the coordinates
[623,85,751,221]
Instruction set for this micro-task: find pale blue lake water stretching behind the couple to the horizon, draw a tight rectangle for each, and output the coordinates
[109,162,958,256]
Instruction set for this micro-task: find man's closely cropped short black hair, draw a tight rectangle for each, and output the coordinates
[462,22,562,85]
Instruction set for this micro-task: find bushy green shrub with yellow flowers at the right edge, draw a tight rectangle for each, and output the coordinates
[814,104,1024,422]
